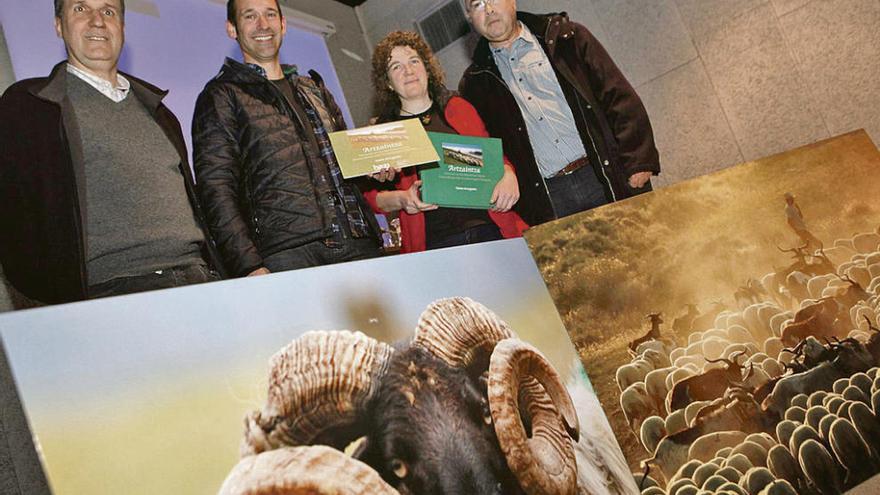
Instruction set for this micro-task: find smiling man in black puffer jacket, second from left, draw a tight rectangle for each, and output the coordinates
[193,0,380,276]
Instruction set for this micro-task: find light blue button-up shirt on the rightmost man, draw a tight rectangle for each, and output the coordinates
[492,22,586,177]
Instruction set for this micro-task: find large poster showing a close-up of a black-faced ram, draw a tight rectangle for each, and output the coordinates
[0,239,636,495]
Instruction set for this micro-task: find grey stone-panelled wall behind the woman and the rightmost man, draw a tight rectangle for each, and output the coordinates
[360,0,880,185]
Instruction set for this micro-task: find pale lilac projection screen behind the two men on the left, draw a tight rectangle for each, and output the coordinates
[0,0,353,150]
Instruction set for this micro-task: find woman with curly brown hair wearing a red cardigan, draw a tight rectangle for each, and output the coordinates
[364,31,528,253]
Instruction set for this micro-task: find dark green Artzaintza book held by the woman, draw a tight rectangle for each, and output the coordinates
[419,132,504,210]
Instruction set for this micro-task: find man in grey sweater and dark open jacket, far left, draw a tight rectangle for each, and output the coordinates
[0,0,218,303]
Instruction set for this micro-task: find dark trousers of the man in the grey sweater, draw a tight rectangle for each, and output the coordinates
[89,265,220,299]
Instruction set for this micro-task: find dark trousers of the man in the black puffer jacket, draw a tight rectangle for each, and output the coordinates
[263,237,379,272]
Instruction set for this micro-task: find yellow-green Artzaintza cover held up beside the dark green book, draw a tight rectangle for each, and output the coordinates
[330,119,439,178]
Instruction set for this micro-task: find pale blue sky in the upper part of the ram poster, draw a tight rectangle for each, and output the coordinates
[0,239,567,412]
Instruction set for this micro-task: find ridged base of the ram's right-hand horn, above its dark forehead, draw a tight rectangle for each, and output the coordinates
[412,297,516,368]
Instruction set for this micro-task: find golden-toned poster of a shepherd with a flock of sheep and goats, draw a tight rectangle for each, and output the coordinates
[526,131,880,494]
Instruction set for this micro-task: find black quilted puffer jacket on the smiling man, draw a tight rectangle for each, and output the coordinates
[192,59,369,276]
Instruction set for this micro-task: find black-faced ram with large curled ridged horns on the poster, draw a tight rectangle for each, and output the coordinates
[222,298,581,495]
